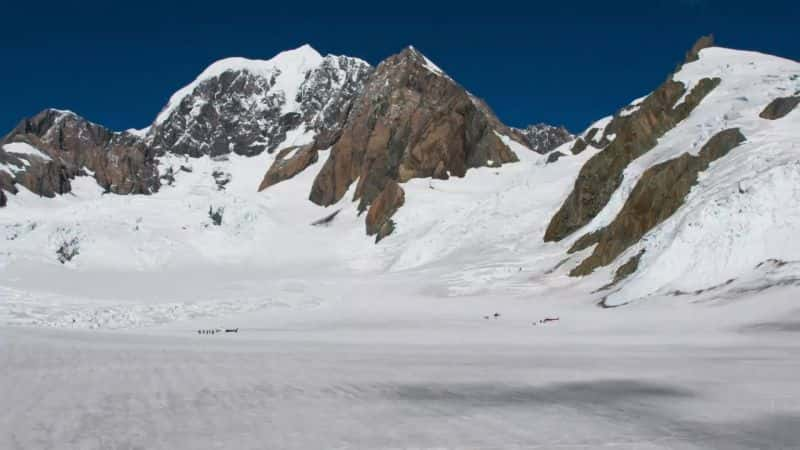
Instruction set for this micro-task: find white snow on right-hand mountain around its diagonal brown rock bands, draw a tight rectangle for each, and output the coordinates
[576,48,800,305]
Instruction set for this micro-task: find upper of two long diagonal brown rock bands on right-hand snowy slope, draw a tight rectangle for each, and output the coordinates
[544,78,721,241]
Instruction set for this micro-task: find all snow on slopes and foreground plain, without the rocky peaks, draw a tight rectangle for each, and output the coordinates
[0,44,800,449]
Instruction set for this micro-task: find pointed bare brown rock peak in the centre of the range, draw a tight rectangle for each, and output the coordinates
[310,47,517,211]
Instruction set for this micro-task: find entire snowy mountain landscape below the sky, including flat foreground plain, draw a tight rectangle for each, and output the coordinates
[0,39,800,449]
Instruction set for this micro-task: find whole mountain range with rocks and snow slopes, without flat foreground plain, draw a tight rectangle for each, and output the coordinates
[0,40,800,326]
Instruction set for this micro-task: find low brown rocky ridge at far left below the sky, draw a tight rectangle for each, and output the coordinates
[0,109,159,197]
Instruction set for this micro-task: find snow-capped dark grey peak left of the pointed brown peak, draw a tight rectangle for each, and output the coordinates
[148,45,372,156]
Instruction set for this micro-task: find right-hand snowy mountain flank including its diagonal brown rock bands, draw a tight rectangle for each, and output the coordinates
[544,37,800,307]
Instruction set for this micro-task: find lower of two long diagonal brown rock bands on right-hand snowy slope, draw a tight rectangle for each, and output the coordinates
[570,128,745,276]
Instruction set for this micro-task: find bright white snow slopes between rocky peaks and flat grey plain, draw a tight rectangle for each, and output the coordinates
[0,47,800,328]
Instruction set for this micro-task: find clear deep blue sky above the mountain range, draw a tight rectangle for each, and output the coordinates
[0,0,800,134]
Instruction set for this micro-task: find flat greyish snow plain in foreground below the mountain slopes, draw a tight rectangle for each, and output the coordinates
[0,270,800,449]
